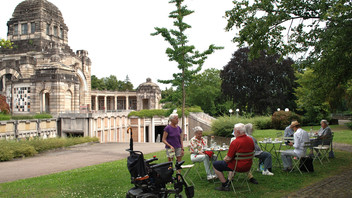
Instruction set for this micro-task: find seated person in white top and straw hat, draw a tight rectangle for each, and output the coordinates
[281,121,309,171]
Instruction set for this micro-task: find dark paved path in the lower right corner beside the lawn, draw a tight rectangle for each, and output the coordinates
[287,143,352,198]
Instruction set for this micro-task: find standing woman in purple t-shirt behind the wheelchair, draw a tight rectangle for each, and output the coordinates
[162,113,184,162]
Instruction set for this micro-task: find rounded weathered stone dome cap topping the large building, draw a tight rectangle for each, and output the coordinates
[8,0,67,29]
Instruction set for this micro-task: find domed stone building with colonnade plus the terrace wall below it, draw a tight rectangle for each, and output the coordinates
[0,0,209,142]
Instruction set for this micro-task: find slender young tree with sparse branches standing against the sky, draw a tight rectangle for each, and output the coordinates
[151,0,222,131]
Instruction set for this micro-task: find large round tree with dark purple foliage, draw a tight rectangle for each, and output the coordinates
[220,48,295,114]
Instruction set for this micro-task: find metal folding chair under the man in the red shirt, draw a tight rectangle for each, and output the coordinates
[229,151,255,193]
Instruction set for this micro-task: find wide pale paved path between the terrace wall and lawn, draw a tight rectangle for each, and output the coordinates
[0,143,164,183]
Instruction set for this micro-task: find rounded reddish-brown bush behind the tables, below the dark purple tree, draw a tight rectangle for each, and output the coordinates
[271,111,301,130]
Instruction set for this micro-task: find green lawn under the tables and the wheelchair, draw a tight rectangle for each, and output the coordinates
[0,126,352,197]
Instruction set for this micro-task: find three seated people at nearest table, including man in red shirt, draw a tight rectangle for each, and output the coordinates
[190,123,274,190]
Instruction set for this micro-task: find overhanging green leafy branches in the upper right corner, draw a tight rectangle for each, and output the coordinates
[226,0,352,92]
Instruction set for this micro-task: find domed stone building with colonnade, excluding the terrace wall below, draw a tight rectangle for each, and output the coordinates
[0,0,161,115]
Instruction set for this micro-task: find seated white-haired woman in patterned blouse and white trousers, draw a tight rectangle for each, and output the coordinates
[190,126,216,180]
